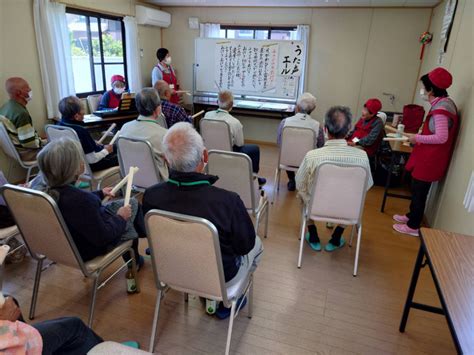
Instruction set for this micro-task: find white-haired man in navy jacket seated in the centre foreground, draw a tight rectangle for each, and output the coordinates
[143,122,263,318]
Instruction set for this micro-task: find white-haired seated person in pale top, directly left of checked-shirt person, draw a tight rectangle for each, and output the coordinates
[277,92,324,191]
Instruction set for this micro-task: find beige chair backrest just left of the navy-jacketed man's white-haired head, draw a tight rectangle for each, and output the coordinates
[117,137,161,189]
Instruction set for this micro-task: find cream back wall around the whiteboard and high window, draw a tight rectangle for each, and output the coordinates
[162,7,432,142]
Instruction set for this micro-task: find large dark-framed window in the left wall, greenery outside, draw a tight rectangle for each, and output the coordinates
[66,8,127,97]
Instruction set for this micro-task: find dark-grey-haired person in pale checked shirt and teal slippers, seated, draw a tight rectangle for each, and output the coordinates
[296,106,373,252]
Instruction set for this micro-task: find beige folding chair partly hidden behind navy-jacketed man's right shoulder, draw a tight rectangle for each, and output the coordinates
[207,150,269,238]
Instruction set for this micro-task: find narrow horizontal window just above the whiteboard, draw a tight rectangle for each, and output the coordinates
[220,25,296,40]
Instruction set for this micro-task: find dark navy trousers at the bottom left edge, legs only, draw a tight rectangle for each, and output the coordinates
[33,317,103,355]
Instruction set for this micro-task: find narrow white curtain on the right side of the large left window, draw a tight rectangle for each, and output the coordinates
[123,16,142,92]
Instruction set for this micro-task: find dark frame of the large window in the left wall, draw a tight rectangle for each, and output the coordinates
[66,7,128,98]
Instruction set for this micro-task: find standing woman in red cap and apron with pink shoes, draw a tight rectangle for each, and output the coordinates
[393,68,459,236]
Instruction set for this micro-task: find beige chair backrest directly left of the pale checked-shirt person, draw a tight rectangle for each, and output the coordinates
[279,126,316,167]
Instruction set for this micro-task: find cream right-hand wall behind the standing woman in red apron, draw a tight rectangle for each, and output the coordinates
[415,0,474,235]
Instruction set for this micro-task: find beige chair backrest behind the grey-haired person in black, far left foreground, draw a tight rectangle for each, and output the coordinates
[1,184,87,275]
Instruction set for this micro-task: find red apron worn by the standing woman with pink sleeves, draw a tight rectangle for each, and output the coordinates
[405,98,459,182]
